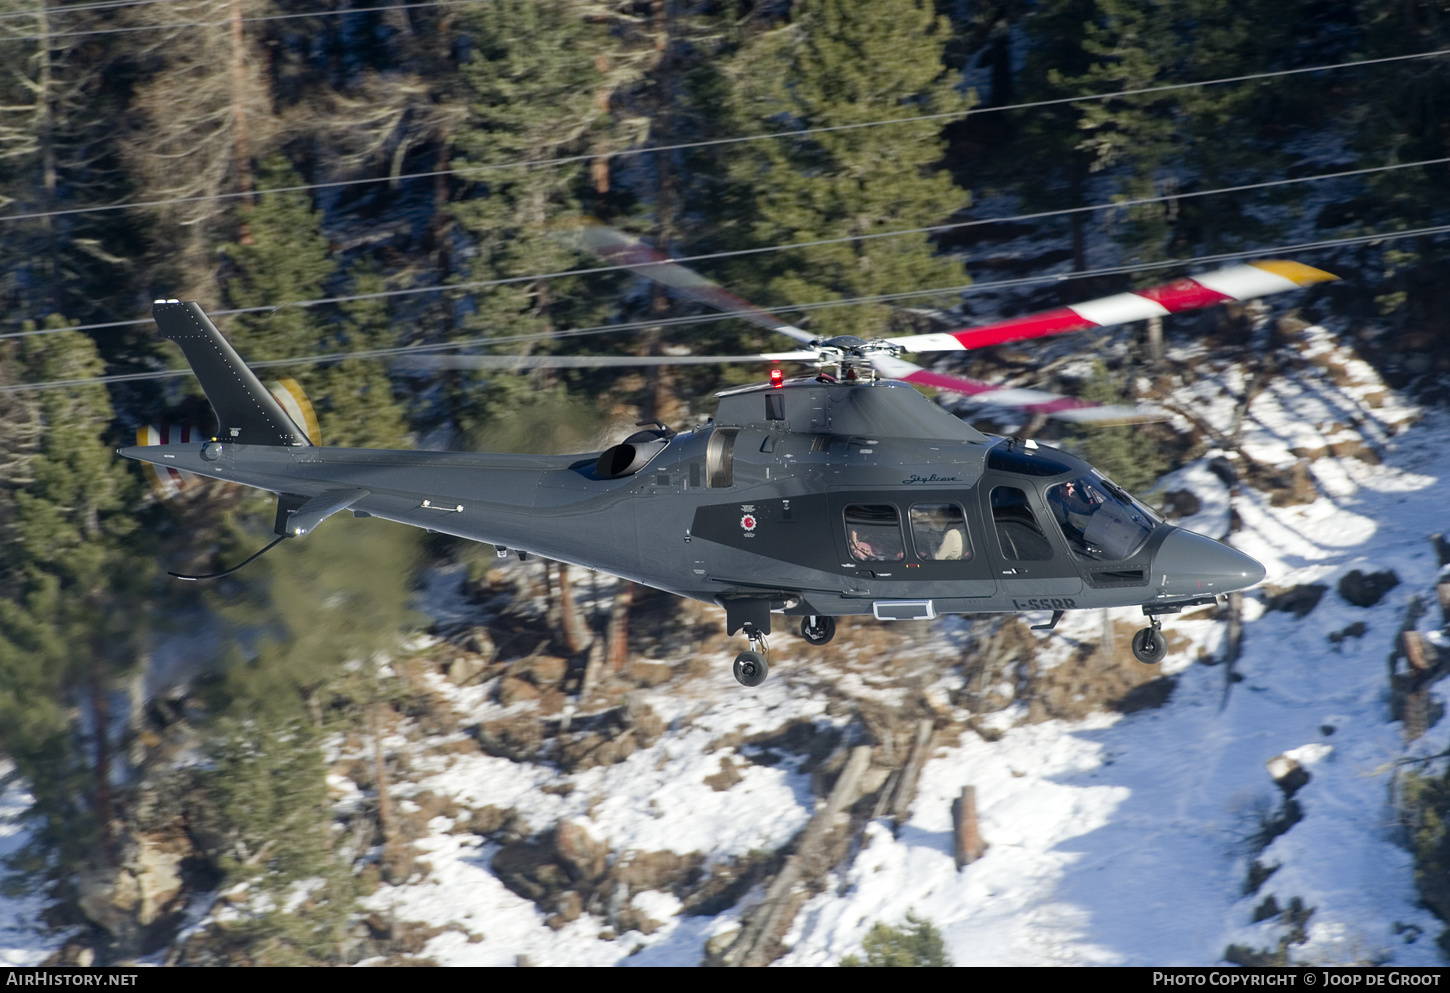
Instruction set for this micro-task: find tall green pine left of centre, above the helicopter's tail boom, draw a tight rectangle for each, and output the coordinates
[440,0,622,432]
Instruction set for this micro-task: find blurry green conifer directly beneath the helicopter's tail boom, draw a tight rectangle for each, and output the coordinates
[195,519,418,965]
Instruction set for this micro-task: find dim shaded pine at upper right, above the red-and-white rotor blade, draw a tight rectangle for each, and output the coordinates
[1028,0,1305,266]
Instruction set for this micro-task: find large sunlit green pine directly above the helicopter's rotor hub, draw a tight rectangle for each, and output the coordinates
[721,0,970,338]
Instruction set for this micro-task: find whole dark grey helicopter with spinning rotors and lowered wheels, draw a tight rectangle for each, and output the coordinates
[117,236,1337,687]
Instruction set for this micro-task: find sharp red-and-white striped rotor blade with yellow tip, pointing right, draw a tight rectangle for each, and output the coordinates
[887,259,1340,352]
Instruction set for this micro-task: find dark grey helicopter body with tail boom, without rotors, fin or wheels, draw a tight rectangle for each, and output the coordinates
[122,378,1263,619]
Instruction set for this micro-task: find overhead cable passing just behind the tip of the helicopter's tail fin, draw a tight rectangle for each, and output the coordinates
[0,150,1450,339]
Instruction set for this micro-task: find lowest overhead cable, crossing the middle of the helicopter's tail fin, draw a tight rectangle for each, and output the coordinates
[0,225,1450,393]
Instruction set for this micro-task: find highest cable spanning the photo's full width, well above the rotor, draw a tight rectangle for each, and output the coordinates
[0,47,1450,223]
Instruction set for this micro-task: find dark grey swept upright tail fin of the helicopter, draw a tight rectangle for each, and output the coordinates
[151,300,312,445]
